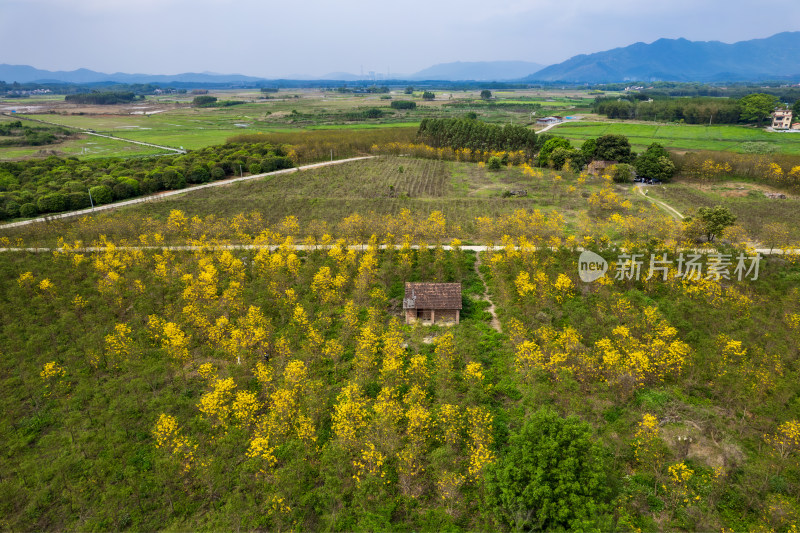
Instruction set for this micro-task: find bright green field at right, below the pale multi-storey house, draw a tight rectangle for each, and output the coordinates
[549,122,800,154]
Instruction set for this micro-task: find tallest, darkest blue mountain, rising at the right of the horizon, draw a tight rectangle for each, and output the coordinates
[523,32,800,83]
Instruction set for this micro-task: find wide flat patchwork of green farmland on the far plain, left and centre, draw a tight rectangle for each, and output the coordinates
[0,90,604,158]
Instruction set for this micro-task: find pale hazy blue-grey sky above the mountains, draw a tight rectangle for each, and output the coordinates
[0,0,800,77]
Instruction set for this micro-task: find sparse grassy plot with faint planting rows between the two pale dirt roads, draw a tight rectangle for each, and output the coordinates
[0,157,649,243]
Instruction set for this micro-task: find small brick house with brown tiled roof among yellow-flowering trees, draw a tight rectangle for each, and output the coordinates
[403,283,461,324]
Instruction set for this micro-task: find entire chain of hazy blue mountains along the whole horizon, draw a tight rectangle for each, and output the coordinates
[0,32,800,86]
